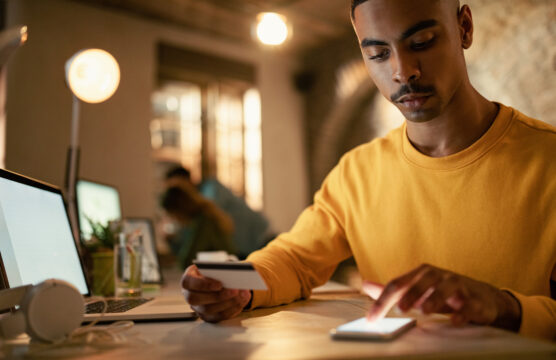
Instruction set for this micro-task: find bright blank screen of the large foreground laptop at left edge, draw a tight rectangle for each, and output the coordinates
[0,170,89,295]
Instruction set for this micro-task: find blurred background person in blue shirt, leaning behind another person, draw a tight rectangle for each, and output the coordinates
[162,167,273,259]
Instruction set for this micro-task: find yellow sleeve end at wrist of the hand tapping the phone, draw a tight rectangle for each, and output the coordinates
[506,289,556,340]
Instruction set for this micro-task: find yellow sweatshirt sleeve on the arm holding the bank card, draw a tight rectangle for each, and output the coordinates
[247,161,351,308]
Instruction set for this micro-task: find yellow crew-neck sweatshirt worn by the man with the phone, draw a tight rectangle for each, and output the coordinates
[248,104,556,339]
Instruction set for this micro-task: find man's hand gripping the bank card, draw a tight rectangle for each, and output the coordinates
[181,265,251,322]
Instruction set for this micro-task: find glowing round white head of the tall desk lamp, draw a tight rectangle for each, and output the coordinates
[66,49,120,103]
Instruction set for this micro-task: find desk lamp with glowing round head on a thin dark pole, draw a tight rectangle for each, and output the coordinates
[65,49,120,244]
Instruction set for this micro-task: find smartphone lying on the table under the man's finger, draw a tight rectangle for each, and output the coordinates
[330,317,416,340]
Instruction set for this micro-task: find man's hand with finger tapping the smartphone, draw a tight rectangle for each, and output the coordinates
[364,264,521,331]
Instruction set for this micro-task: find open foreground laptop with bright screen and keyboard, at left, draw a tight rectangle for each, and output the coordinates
[0,169,197,322]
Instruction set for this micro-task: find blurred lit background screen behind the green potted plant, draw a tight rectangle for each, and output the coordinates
[75,180,122,240]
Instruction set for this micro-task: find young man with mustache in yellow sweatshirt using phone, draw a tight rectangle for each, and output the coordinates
[182,0,556,338]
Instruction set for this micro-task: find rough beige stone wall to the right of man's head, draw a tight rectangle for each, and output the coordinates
[465,0,556,126]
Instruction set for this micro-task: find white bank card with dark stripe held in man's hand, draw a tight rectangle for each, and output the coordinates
[193,261,268,290]
